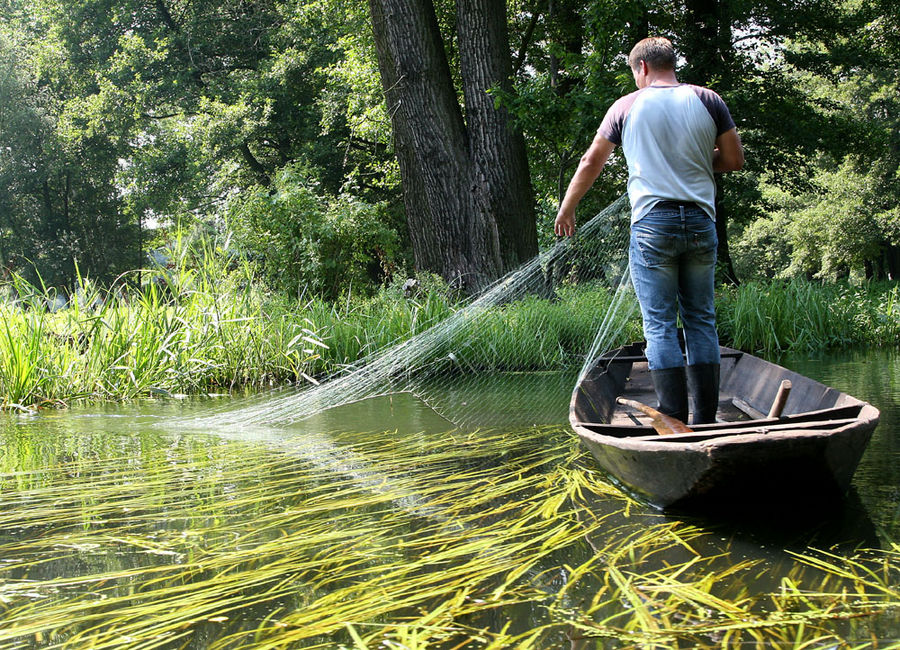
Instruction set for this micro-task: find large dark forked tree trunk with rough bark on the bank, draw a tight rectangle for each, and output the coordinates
[369,0,537,292]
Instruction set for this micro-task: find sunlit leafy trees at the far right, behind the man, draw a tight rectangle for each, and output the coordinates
[739,2,900,279]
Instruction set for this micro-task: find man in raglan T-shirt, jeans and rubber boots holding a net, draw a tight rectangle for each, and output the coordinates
[554,37,744,424]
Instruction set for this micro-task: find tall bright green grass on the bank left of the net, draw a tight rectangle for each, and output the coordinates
[0,239,460,410]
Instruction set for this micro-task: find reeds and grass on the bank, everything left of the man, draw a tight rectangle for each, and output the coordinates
[0,266,628,408]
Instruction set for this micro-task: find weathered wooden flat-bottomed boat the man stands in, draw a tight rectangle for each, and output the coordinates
[569,342,879,510]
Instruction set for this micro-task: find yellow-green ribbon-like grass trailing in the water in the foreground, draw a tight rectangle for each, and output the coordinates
[0,420,900,649]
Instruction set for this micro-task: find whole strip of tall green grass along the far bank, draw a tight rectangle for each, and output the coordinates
[0,234,900,409]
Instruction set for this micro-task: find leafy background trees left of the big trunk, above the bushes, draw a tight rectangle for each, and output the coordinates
[0,0,396,284]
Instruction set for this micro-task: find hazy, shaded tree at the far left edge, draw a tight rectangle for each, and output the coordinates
[0,23,136,286]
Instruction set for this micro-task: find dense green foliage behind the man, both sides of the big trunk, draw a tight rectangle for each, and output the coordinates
[0,0,900,290]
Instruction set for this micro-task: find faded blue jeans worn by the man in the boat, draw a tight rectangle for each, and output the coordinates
[629,204,719,370]
